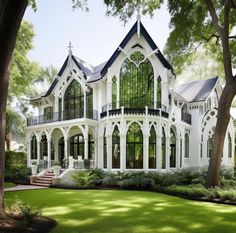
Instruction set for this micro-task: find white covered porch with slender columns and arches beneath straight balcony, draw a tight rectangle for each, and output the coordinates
[27,124,97,171]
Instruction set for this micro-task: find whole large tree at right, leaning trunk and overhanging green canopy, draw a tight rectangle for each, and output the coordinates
[85,0,236,187]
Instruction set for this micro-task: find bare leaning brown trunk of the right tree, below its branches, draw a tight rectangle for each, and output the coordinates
[206,81,236,188]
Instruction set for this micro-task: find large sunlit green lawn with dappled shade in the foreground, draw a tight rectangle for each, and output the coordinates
[5,189,236,233]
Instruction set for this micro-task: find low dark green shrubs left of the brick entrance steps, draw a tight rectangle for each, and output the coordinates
[5,164,31,184]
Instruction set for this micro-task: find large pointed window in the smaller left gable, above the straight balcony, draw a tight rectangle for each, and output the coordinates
[64,80,84,119]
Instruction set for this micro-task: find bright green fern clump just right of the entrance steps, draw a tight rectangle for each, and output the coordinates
[71,170,98,187]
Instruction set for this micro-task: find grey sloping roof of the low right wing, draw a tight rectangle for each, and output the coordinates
[174,77,218,103]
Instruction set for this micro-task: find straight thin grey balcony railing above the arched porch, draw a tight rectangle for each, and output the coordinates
[27,109,98,126]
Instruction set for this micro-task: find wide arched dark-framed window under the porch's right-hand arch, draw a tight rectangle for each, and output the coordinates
[70,134,84,159]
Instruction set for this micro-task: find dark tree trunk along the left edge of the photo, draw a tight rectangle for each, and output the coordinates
[0,0,28,217]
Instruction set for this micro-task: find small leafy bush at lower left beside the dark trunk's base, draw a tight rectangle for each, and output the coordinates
[6,199,43,224]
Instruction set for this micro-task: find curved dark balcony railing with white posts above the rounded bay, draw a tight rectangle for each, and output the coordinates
[100,102,169,118]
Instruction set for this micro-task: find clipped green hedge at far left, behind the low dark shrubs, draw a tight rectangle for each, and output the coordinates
[5,151,27,168]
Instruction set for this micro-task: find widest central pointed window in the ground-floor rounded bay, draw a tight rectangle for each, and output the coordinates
[126,122,143,169]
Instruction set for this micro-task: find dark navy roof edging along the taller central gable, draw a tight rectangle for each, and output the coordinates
[100,21,173,79]
